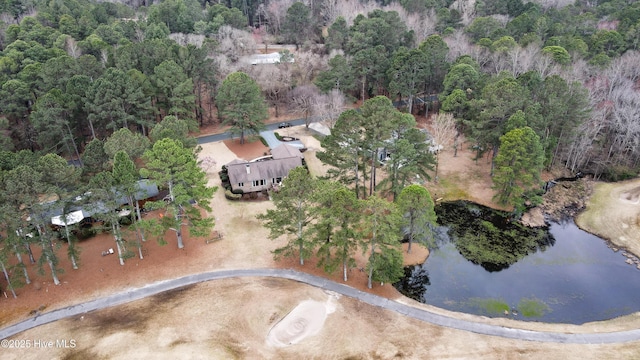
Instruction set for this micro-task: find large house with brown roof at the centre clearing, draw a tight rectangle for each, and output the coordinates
[226,144,302,193]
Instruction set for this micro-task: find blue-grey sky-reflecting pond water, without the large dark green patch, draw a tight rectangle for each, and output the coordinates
[395,202,640,324]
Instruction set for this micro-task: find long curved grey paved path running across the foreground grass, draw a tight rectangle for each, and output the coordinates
[0,269,640,344]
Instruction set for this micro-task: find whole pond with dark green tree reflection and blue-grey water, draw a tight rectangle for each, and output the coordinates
[395,202,640,324]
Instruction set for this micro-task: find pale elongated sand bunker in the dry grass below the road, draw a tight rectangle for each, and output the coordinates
[267,297,335,347]
